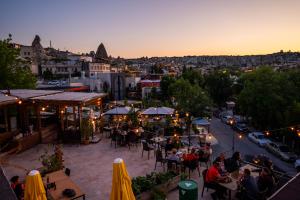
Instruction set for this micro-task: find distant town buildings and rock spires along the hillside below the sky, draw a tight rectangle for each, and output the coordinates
[14,35,300,100]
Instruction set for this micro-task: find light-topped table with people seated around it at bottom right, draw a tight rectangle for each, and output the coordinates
[218,164,259,199]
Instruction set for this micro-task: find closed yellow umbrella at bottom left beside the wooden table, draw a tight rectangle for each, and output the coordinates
[24,170,47,200]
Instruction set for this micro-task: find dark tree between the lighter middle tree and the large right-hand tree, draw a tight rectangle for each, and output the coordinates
[204,70,233,107]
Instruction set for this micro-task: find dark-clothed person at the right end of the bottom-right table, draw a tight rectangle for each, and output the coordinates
[257,168,275,195]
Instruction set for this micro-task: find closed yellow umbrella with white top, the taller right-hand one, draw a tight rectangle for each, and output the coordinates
[110,158,135,200]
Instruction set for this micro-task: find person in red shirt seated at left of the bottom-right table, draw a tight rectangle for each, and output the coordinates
[205,161,227,199]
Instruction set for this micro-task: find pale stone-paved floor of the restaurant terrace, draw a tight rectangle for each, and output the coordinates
[3,139,218,200]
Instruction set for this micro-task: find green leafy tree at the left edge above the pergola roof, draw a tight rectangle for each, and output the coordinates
[0,35,36,90]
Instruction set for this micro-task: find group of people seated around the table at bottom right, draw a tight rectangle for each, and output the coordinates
[204,152,278,200]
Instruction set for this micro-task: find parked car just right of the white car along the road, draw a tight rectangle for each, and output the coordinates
[266,142,297,162]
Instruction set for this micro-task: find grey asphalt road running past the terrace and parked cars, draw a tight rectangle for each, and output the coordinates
[210,118,296,176]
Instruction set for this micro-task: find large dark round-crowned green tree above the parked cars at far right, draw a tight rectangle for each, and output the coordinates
[238,67,299,130]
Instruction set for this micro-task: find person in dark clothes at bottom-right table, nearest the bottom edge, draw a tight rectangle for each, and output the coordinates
[240,169,259,199]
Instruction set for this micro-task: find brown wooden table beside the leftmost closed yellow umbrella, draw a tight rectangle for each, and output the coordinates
[43,170,85,200]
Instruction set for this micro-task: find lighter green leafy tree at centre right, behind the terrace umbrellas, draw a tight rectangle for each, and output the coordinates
[170,78,211,117]
